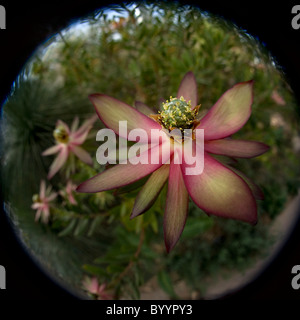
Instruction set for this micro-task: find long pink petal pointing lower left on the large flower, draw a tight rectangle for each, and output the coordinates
[76,145,170,193]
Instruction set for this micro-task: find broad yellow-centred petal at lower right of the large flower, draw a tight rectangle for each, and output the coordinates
[181,152,257,224]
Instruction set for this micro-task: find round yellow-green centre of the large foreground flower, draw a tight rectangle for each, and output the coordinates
[159,97,199,131]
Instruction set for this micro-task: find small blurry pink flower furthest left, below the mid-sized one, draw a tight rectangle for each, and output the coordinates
[31,180,57,224]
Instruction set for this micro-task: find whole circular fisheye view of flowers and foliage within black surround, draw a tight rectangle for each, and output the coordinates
[1,2,300,300]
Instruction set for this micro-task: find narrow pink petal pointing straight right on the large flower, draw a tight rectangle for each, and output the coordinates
[205,139,269,158]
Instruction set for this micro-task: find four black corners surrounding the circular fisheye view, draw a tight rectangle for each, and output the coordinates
[0,0,300,301]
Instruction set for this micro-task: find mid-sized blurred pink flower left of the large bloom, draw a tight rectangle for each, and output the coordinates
[42,116,97,179]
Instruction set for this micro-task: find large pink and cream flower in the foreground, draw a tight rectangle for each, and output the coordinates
[77,72,269,252]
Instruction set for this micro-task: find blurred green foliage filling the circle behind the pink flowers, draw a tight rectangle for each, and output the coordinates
[1,2,300,299]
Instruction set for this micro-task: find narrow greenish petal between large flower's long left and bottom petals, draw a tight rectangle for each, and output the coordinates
[130,164,169,219]
